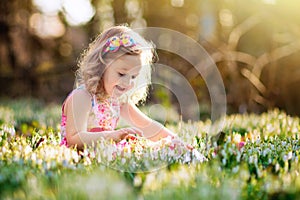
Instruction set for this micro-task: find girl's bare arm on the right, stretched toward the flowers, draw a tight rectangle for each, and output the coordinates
[121,103,176,141]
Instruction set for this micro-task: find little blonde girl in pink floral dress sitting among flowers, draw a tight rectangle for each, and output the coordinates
[61,26,189,148]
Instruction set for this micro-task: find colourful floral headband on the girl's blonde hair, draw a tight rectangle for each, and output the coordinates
[103,34,137,54]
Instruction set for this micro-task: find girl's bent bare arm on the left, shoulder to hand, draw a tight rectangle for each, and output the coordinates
[63,90,140,148]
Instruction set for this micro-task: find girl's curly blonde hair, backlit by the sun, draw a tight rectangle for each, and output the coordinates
[76,25,157,104]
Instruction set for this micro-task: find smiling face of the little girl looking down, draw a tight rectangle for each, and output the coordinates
[103,54,142,97]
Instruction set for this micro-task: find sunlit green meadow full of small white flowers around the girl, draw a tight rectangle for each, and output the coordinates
[0,99,300,199]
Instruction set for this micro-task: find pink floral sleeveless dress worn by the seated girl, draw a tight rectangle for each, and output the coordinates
[60,87,120,146]
